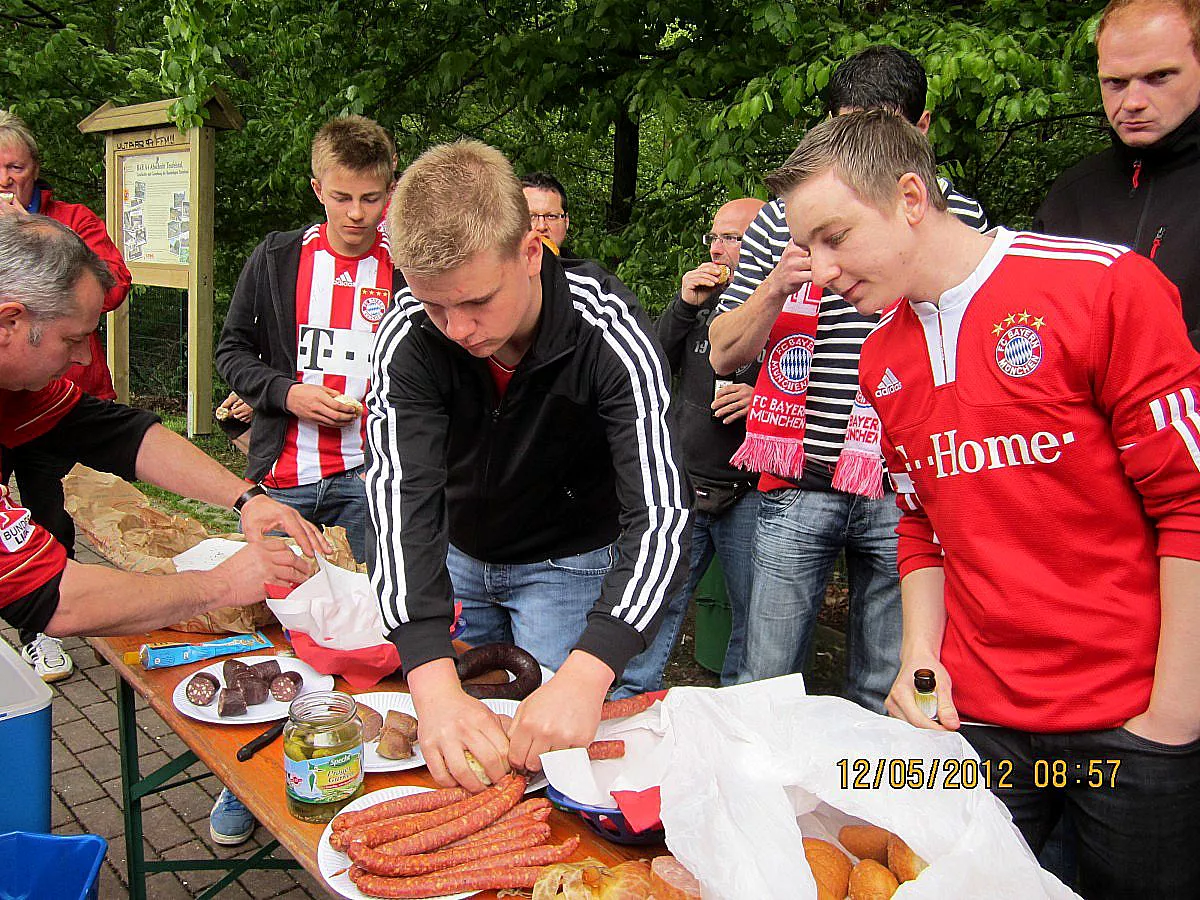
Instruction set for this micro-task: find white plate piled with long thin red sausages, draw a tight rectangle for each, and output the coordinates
[317,775,578,900]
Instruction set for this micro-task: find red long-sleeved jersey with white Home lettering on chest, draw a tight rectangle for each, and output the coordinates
[859,229,1200,732]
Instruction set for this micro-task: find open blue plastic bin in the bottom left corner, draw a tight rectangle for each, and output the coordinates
[0,832,108,900]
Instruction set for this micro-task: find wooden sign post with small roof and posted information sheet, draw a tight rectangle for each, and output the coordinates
[79,92,244,437]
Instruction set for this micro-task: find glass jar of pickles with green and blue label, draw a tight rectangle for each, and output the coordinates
[283,691,362,822]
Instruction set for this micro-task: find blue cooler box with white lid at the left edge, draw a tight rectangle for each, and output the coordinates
[0,640,54,835]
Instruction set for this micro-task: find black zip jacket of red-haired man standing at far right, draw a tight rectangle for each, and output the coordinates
[1033,108,1200,348]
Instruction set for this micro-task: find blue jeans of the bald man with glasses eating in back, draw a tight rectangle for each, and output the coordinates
[676,491,760,685]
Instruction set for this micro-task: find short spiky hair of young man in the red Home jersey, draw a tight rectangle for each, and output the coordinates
[767,109,946,211]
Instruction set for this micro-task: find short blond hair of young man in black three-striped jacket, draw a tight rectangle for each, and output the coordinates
[388,140,529,276]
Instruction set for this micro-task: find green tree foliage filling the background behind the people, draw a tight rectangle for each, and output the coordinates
[0,0,1105,307]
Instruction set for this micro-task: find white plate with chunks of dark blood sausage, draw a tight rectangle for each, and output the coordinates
[172,655,334,725]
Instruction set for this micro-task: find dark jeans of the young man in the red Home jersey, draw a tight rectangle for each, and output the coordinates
[962,725,1200,900]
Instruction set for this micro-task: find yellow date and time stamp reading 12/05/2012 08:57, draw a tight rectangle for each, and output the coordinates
[836,756,1121,791]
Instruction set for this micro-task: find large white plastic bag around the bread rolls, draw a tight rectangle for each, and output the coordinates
[661,676,1075,900]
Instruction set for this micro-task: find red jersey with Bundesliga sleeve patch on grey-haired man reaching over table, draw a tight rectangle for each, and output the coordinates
[0,378,83,607]
